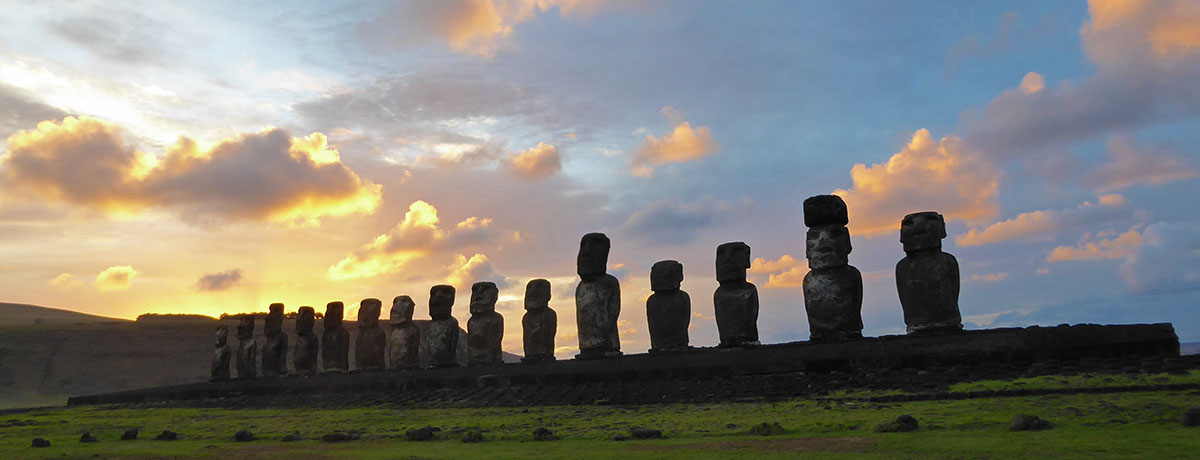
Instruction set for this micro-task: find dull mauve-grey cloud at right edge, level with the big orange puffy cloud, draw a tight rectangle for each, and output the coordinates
[1082,136,1200,192]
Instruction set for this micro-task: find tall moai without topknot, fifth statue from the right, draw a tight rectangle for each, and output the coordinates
[575,233,620,359]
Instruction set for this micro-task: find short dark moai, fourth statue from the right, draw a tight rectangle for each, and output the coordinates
[646,261,691,352]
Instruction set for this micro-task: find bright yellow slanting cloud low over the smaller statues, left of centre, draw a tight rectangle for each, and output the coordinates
[325,201,493,281]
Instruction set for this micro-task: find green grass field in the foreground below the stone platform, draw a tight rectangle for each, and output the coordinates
[0,371,1200,459]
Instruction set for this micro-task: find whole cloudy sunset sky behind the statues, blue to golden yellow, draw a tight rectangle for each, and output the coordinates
[0,0,1200,357]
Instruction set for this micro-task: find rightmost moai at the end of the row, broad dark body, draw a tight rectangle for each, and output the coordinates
[896,211,962,334]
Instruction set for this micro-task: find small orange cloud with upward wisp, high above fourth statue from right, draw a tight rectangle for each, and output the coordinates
[634,107,720,178]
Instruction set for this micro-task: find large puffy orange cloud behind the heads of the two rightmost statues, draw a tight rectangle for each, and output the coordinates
[834,130,1001,237]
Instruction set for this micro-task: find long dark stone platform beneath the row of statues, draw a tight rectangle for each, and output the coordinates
[67,323,1180,406]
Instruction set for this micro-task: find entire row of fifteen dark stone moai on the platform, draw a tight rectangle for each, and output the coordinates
[212,195,962,380]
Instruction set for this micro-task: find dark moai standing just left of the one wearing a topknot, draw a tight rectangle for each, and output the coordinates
[713,241,758,347]
